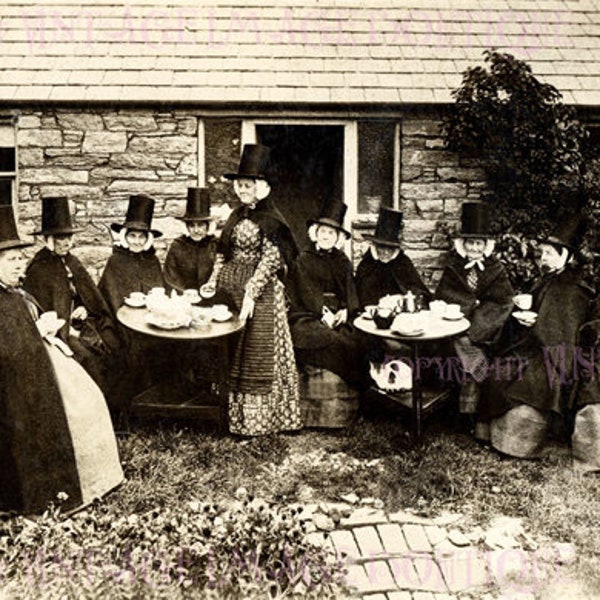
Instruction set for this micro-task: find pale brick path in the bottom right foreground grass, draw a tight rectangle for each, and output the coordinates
[305,504,575,600]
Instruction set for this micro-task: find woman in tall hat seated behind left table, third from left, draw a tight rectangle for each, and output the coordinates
[98,195,165,314]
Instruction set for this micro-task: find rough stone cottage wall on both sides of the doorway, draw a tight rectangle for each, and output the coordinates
[12,108,483,287]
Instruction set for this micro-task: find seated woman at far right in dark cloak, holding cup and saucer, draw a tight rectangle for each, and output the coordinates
[477,217,592,458]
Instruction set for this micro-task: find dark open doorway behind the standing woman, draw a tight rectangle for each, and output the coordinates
[256,125,344,250]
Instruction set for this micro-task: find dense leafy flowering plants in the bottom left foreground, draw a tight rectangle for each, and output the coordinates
[0,490,345,599]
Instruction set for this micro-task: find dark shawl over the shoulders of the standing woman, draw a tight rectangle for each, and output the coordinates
[218,198,298,279]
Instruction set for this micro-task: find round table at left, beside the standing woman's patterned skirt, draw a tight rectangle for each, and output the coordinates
[117,305,245,427]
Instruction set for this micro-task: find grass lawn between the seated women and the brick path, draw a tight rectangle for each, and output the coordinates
[0,406,600,599]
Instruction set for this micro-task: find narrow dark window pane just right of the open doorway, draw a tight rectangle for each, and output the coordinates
[358,121,396,213]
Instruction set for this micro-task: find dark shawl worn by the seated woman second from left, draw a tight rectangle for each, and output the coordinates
[23,248,119,351]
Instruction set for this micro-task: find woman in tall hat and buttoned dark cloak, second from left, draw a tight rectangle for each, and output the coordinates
[23,197,120,393]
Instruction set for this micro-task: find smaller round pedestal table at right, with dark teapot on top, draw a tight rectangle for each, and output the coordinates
[354,311,471,441]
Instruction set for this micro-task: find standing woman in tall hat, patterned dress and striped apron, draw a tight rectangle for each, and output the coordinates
[207,144,302,435]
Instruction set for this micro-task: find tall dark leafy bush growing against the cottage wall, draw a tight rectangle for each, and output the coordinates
[443,51,586,287]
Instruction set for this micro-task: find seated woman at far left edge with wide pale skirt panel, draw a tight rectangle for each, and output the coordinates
[0,205,123,513]
